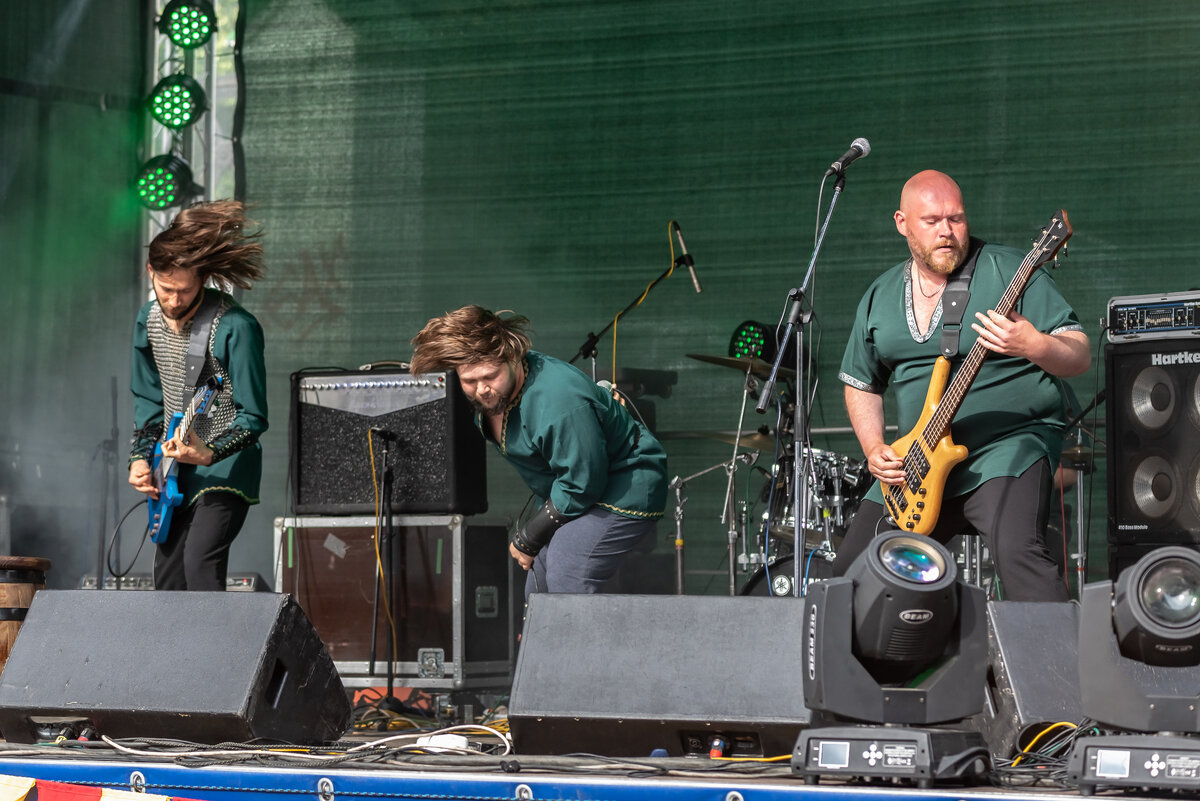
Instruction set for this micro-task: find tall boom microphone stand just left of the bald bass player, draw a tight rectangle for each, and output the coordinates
[755,169,846,597]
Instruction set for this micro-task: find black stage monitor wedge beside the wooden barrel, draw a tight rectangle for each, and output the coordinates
[0,590,352,745]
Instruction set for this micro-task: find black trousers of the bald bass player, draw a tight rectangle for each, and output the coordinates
[833,459,1068,601]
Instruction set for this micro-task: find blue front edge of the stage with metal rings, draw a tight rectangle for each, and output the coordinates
[0,745,1099,801]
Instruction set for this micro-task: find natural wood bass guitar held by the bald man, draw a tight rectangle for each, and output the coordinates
[883,209,1072,535]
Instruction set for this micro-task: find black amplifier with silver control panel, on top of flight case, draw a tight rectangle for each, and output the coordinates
[288,369,487,514]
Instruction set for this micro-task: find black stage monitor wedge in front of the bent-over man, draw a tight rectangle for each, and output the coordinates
[509,592,809,757]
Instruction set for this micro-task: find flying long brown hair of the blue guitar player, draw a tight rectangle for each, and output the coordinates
[148,200,264,289]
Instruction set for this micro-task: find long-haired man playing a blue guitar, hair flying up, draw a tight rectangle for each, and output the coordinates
[130,200,268,590]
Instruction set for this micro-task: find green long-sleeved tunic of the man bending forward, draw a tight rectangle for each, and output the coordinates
[475,350,667,518]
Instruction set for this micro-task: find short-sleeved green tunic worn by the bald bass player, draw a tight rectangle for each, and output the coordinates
[839,245,1081,502]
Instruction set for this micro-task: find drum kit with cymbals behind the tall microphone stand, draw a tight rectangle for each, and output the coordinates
[671,354,871,596]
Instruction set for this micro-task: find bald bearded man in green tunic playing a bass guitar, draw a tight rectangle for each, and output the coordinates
[833,170,1091,601]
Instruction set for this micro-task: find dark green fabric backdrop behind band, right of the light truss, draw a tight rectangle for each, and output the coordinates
[231,0,1200,592]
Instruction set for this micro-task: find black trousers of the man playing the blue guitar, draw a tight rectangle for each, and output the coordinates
[154,492,250,590]
